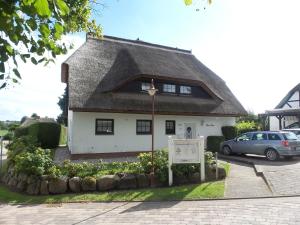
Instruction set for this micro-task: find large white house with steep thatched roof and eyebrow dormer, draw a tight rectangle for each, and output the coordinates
[62,36,246,157]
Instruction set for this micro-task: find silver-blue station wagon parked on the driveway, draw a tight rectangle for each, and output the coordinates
[220,131,300,161]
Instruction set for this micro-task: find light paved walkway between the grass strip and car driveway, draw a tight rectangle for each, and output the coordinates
[225,162,272,198]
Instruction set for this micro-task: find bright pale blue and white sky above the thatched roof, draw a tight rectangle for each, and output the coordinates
[0,0,300,120]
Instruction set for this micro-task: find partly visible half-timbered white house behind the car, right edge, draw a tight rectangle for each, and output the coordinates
[264,83,300,130]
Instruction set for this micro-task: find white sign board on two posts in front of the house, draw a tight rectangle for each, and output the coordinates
[169,136,205,186]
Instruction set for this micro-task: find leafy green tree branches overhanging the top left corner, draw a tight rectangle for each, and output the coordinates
[0,0,101,89]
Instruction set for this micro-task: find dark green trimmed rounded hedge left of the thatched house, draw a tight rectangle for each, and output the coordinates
[15,122,61,148]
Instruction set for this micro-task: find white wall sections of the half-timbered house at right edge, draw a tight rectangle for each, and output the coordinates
[270,91,300,131]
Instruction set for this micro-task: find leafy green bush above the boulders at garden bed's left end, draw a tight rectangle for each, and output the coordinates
[15,148,54,176]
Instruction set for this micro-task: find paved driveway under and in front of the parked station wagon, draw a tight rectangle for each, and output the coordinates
[221,156,300,195]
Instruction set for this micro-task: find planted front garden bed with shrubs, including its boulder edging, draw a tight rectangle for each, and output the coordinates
[1,137,226,195]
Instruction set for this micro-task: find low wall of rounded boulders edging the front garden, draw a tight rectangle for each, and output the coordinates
[1,163,226,195]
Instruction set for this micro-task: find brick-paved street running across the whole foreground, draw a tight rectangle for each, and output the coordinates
[0,197,300,225]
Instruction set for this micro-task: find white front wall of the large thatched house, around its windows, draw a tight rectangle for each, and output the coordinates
[68,112,235,154]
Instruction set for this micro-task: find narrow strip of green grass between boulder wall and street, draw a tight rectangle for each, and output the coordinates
[0,181,224,204]
